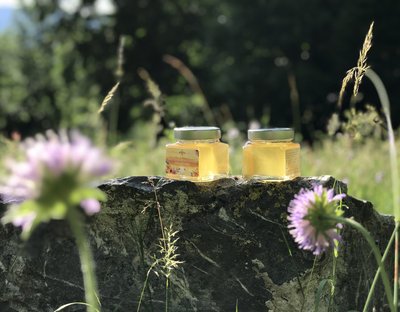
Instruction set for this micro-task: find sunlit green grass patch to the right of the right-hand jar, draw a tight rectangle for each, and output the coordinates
[302,137,399,213]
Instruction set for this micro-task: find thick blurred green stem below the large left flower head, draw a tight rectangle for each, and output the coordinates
[67,207,100,312]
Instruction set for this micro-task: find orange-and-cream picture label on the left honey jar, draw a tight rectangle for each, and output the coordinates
[166,148,199,177]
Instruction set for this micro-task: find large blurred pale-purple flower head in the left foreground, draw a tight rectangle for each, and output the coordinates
[0,131,112,238]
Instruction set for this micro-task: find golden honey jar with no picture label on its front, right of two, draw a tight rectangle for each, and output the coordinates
[242,128,300,180]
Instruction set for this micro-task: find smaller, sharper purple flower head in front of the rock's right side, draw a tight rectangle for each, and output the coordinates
[288,185,346,255]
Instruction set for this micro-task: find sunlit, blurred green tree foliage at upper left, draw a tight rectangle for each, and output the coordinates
[0,1,104,135]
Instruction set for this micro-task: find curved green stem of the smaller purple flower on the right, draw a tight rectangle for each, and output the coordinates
[329,217,396,312]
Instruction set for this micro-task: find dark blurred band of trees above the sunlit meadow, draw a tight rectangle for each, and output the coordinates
[0,0,400,139]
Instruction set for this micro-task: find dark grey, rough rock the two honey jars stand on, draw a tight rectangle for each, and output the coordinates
[0,176,393,312]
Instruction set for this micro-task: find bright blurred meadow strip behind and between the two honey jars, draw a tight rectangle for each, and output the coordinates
[0,118,392,214]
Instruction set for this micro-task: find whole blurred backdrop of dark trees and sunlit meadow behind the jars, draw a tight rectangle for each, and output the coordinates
[0,0,400,212]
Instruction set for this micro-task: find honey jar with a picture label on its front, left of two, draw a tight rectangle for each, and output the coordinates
[166,127,229,182]
